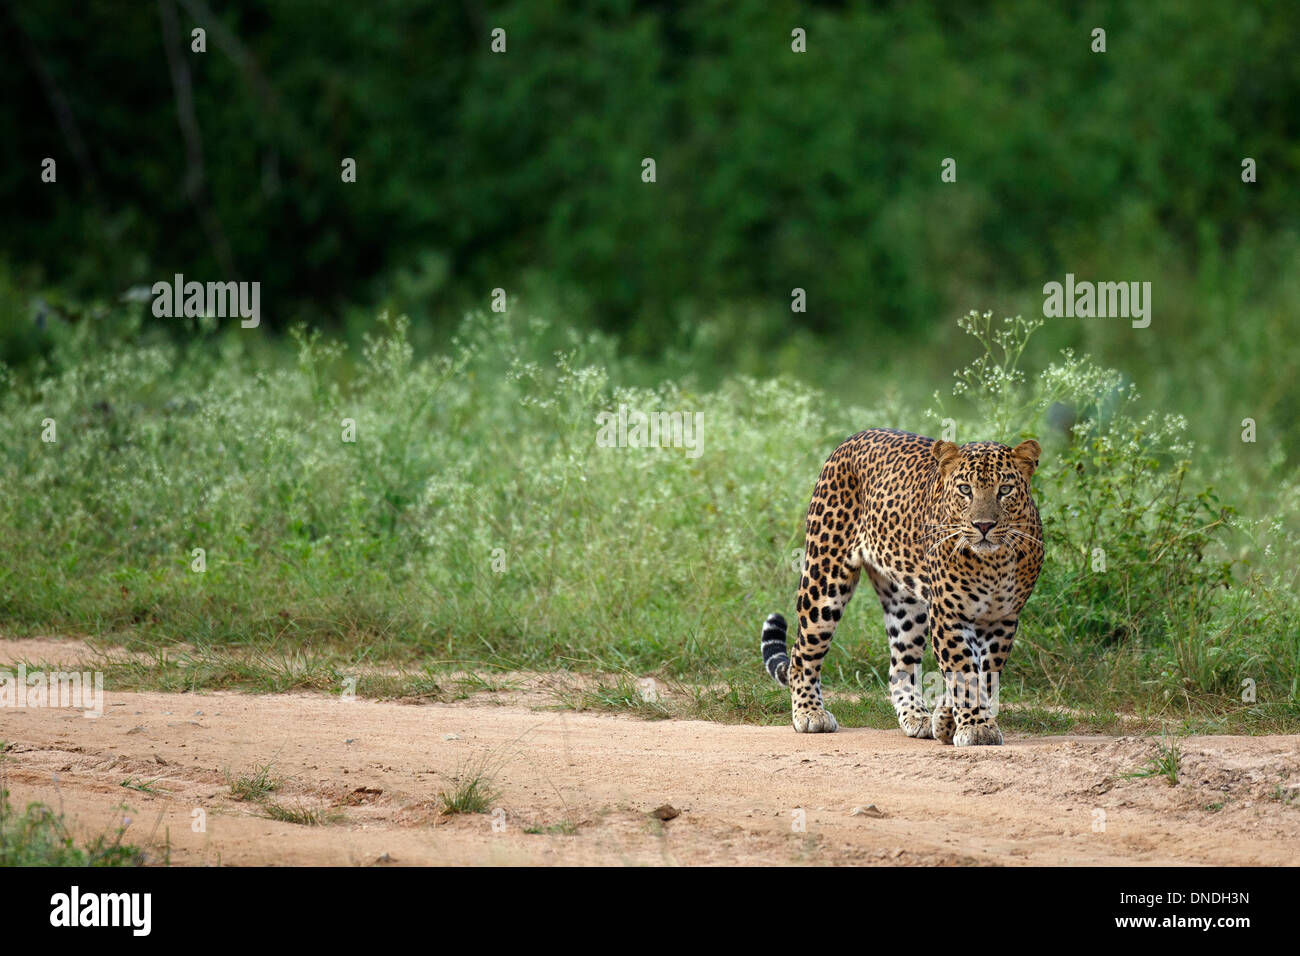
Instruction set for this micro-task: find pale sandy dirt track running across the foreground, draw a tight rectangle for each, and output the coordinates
[0,641,1300,865]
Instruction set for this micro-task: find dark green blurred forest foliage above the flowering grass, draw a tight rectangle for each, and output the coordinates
[0,0,1300,371]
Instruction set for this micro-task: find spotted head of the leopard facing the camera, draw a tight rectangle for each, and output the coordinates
[931,441,1041,554]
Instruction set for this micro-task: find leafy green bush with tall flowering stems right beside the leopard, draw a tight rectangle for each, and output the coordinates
[936,312,1245,693]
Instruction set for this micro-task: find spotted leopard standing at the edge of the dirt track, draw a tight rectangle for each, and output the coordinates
[759,428,1044,747]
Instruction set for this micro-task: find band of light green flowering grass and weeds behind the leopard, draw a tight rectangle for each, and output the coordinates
[0,303,1300,732]
